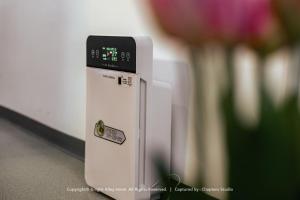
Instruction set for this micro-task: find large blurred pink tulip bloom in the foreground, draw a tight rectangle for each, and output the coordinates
[150,0,278,49]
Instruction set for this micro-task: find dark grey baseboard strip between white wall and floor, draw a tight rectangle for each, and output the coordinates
[0,106,85,160]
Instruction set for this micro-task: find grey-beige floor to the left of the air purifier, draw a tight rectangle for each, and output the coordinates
[0,117,108,200]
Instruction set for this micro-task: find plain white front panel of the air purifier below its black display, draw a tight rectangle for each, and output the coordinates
[85,67,140,200]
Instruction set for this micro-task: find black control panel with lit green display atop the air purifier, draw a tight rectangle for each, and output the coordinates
[86,36,136,73]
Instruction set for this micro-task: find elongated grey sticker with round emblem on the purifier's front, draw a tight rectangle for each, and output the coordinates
[94,120,126,145]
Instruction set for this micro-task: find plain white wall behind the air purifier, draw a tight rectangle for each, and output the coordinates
[0,0,185,139]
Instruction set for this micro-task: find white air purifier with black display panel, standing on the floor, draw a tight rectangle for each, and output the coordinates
[85,36,172,200]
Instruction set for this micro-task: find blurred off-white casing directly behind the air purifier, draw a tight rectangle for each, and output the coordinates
[153,60,192,180]
